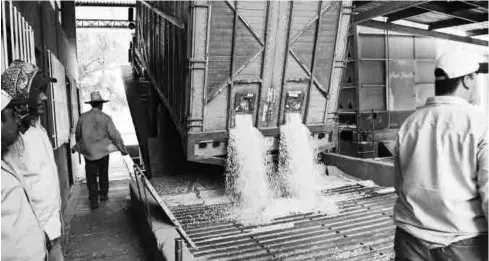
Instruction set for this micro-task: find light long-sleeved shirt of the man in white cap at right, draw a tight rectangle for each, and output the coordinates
[394,96,489,248]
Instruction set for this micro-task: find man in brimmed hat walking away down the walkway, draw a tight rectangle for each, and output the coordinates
[73,91,127,209]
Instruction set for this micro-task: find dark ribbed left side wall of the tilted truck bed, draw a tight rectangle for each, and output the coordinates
[136,1,188,125]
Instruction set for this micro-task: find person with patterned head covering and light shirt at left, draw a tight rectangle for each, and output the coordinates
[2,60,64,261]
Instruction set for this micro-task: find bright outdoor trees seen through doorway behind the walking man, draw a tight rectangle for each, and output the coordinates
[77,28,137,181]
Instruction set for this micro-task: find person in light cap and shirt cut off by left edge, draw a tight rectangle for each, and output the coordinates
[1,90,47,261]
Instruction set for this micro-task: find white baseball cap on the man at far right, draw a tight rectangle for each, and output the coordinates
[435,50,487,81]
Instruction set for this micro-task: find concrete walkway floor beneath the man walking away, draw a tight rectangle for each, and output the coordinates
[63,173,147,261]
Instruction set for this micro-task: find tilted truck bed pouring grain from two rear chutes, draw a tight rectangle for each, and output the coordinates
[131,1,352,165]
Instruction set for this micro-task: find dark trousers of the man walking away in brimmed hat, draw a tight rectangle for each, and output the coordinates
[85,155,109,202]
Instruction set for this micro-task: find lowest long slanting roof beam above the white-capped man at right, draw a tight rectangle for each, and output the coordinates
[362,21,489,46]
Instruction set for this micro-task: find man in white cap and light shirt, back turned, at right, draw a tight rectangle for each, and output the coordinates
[394,51,489,261]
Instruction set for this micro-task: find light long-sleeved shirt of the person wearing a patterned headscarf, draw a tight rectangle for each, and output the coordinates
[4,120,62,240]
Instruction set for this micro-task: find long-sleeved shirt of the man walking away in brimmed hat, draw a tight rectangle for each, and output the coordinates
[73,108,126,160]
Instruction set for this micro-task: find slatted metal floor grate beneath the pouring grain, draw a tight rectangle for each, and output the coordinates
[168,184,396,261]
